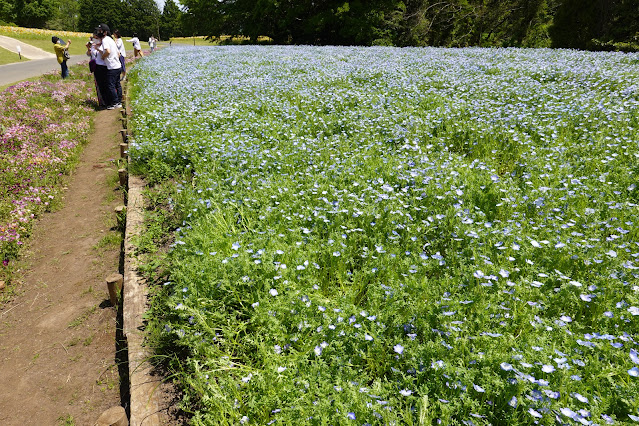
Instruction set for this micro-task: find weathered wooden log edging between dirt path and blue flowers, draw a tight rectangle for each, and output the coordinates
[122,84,161,426]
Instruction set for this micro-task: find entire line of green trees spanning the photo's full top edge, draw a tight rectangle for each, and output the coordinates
[0,0,639,50]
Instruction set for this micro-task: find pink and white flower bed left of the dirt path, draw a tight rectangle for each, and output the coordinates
[0,73,93,266]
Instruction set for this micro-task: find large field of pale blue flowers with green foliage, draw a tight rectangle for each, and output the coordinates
[130,47,639,425]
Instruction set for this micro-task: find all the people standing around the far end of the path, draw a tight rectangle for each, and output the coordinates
[51,24,157,110]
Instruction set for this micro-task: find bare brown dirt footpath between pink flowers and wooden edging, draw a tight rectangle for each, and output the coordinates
[0,110,122,426]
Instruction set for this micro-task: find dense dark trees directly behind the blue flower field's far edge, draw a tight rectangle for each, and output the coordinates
[182,0,639,49]
